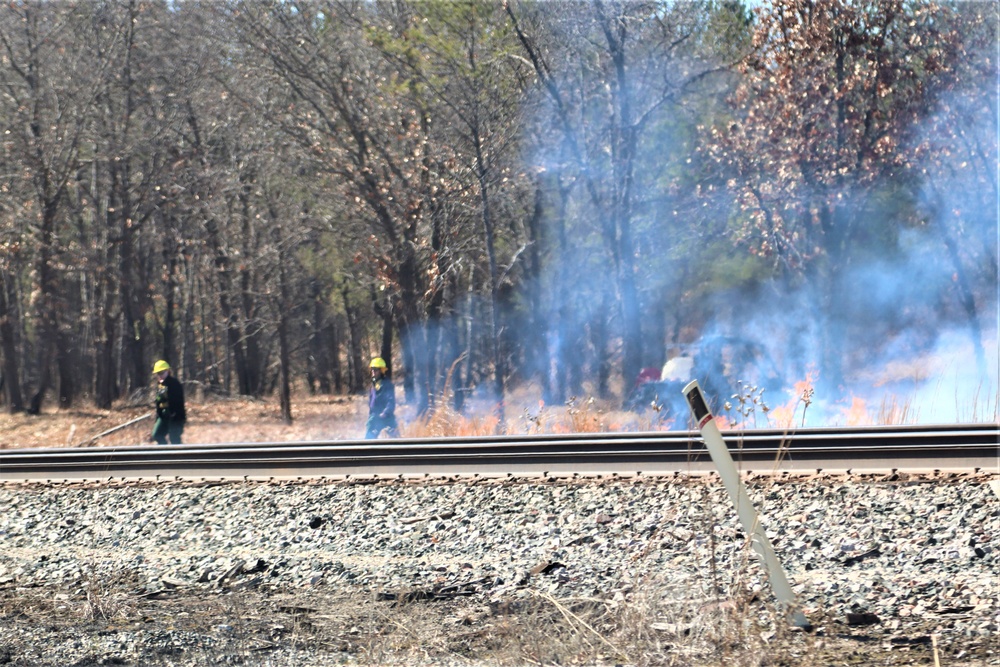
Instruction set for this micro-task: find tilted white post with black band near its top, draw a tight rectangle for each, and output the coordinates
[683,380,812,629]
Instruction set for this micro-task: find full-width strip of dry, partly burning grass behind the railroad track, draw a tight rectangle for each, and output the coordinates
[0,378,998,449]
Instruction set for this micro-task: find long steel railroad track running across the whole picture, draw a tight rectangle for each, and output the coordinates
[0,424,1000,482]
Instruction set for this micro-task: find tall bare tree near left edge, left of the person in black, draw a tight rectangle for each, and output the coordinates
[0,2,107,413]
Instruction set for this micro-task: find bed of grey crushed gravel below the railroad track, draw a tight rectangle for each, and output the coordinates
[0,474,1000,667]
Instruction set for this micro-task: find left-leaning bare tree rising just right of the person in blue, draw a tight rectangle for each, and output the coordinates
[235,3,468,409]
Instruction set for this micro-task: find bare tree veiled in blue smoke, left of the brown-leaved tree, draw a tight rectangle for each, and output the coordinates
[505,0,736,391]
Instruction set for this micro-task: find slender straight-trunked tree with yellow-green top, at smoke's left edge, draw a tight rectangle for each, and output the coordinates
[378,2,533,423]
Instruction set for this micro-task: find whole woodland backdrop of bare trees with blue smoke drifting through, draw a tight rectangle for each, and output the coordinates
[0,0,1000,421]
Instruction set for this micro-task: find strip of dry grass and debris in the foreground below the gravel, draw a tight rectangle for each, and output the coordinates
[0,565,968,667]
